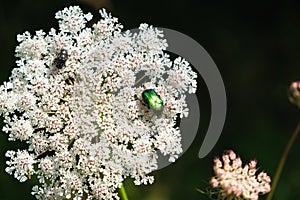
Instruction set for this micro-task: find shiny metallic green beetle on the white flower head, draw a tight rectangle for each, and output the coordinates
[142,89,164,111]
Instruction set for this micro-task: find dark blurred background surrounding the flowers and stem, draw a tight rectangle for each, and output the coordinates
[0,0,300,200]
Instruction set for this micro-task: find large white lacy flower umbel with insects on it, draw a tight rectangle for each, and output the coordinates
[0,6,196,199]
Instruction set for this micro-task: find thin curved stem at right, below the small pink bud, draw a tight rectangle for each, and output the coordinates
[267,121,300,200]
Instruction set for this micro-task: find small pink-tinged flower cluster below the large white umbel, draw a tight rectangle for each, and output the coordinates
[210,150,271,200]
